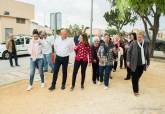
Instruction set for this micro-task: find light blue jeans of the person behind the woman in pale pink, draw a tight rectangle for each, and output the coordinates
[44,53,53,71]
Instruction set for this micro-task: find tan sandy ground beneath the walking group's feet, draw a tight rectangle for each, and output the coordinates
[0,61,165,114]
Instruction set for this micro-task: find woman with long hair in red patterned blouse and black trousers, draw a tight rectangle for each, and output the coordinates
[71,34,92,91]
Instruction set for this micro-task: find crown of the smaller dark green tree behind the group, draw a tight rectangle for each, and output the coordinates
[104,8,137,33]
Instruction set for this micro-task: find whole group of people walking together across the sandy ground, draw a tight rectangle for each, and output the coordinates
[6,29,150,96]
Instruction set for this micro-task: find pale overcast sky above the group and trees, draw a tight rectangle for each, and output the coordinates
[17,0,165,31]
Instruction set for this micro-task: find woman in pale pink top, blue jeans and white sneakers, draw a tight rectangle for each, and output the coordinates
[27,29,45,91]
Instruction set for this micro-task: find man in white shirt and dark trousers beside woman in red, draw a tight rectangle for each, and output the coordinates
[49,29,74,91]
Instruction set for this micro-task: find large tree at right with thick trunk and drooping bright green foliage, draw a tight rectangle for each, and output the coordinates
[109,0,165,57]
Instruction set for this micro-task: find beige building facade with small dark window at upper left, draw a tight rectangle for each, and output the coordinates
[0,0,34,42]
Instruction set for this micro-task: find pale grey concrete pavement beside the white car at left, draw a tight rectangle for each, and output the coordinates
[0,53,74,86]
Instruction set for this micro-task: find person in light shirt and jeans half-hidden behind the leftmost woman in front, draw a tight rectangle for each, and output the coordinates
[41,32,53,72]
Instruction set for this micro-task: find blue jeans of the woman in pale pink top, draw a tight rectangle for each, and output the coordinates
[29,58,44,86]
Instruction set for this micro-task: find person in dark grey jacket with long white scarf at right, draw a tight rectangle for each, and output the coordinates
[127,31,150,96]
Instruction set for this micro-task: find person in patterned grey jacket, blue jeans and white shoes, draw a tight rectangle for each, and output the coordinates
[97,34,113,89]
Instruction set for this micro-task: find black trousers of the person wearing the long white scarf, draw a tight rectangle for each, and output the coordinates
[132,65,144,93]
